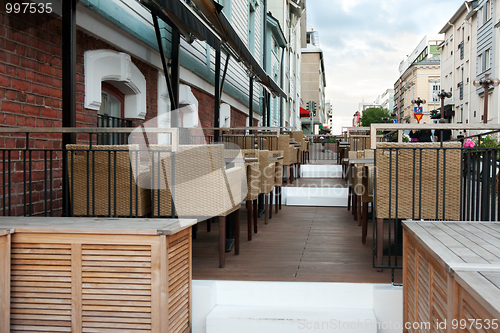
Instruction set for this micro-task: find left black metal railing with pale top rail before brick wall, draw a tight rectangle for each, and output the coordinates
[0,128,179,217]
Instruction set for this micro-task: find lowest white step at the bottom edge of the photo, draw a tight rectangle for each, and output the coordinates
[206,305,377,333]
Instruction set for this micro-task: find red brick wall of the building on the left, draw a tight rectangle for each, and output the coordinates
[0,5,158,216]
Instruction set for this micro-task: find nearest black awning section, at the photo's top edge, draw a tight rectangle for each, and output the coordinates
[139,0,221,49]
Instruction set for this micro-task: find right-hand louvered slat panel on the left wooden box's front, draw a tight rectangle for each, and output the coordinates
[82,244,152,332]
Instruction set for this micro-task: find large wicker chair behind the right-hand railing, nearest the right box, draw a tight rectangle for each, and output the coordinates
[374,142,462,265]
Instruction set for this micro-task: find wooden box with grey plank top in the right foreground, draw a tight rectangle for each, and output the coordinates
[403,221,500,332]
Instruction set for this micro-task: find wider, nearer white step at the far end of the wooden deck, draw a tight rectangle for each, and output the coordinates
[282,187,349,207]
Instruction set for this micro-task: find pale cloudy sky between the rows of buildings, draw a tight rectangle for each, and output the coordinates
[307,0,463,126]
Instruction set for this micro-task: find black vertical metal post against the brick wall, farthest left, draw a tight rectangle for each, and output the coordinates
[62,0,77,216]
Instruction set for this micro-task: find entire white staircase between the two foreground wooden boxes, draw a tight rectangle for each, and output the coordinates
[193,281,402,333]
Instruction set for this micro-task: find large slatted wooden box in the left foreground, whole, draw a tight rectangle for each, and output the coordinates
[0,217,196,332]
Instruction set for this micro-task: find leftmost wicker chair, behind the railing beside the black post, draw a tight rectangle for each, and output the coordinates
[66,144,151,217]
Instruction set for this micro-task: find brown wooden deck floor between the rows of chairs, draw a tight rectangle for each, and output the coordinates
[193,206,401,283]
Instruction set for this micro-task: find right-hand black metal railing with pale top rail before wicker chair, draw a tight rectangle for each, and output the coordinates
[372,124,500,277]
